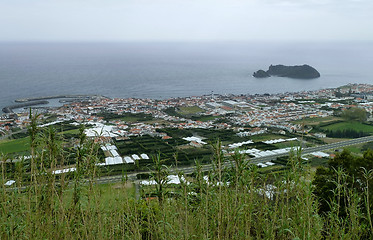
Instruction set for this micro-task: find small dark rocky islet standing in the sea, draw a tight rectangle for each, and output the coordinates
[253,64,320,79]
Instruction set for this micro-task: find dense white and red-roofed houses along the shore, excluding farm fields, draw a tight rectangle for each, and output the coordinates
[0,84,373,144]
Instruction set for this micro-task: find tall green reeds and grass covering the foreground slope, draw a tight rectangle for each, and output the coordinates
[0,116,372,239]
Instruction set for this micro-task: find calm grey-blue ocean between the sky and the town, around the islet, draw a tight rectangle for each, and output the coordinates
[0,42,373,109]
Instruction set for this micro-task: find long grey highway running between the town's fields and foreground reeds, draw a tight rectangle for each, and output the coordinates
[93,136,373,183]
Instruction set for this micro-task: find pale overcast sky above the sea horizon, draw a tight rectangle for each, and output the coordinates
[0,0,373,41]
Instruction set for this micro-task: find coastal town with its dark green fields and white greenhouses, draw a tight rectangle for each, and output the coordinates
[0,84,373,171]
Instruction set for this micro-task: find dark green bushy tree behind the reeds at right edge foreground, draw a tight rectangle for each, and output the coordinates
[312,149,373,239]
